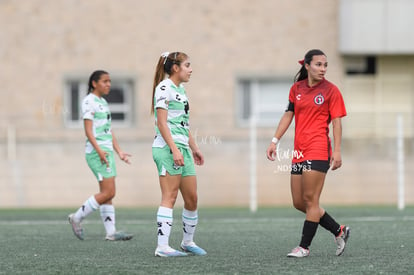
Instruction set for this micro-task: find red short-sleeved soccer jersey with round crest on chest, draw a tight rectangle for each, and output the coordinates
[289,79,346,163]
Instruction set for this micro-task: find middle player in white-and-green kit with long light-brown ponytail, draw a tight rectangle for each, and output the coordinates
[151,52,207,257]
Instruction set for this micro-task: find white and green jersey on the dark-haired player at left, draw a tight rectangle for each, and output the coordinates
[82,93,113,154]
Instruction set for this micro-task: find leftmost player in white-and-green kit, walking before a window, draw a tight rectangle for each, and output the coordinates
[69,71,132,241]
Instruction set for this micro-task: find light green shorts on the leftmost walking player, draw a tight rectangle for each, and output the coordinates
[86,151,116,182]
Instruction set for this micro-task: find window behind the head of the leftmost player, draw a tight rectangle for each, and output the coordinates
[64,75,134,127]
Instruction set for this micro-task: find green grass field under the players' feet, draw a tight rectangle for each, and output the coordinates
[0,207,414,274]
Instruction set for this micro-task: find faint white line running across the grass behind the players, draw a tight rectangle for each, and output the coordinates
[0,216,414,226]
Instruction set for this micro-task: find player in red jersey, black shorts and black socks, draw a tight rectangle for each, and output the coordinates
[267,50,350,258]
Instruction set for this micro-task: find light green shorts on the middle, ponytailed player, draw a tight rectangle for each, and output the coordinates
[152,145,196,177]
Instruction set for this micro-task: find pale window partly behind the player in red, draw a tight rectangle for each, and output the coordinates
[237,79,293,127]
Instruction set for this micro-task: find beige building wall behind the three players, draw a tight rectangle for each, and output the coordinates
[0,0,414,207]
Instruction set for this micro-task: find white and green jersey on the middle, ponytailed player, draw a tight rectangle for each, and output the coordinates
[152,79,190,148]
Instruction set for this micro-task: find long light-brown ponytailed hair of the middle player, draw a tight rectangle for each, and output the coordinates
[151,52,188,114]
